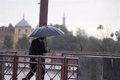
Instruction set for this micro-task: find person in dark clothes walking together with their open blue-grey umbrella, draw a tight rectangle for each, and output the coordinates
[22,26,64,80]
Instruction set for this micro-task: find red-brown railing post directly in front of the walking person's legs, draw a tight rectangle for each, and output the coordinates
[36,56,42,80]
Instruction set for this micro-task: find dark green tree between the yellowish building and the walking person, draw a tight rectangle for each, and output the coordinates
[16,35,30,49]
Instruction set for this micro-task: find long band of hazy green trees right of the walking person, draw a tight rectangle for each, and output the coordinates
[47,25,120,52]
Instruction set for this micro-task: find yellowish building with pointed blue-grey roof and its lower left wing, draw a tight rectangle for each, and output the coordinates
[0,17,32,49]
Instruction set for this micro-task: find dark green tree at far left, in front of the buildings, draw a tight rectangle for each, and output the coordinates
[3,35,13,49]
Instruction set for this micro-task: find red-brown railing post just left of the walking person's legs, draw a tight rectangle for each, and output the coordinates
[12,54,18,80]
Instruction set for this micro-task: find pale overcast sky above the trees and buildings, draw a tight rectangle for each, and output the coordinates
[0,0,120,35]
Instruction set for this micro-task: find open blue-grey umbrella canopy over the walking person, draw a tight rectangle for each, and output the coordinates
[28,26,64,37]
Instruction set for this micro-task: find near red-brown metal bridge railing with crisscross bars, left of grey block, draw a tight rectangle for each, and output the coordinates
[0,53,78,80]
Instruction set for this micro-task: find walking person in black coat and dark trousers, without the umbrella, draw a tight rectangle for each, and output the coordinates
[22,37,47,80]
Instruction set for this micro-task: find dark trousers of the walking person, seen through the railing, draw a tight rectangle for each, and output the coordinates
[27,60,45,80]
